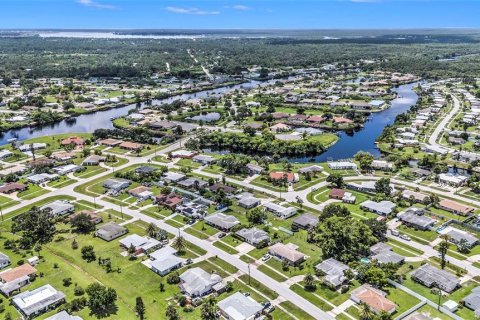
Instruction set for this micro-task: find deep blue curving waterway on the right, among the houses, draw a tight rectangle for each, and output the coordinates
[290,83,418,162]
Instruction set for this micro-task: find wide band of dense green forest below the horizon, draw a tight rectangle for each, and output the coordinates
[0,30,480,78]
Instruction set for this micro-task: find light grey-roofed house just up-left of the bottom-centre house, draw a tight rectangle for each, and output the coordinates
[180,267,222,298]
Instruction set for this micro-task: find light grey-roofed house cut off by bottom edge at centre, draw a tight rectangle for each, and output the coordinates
[217,292,263,320]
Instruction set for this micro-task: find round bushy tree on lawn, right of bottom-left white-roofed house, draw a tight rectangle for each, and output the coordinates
[85,282,117,316]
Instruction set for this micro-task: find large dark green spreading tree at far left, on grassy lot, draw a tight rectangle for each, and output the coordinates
[12,207,56,248]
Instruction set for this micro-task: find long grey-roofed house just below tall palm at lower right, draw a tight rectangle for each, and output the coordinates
[412,264,460,293]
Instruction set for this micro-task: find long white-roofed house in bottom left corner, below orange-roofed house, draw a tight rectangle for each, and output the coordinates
[12,284,65,318]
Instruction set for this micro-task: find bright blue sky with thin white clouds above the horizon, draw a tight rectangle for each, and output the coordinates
[0,0,480,29]
